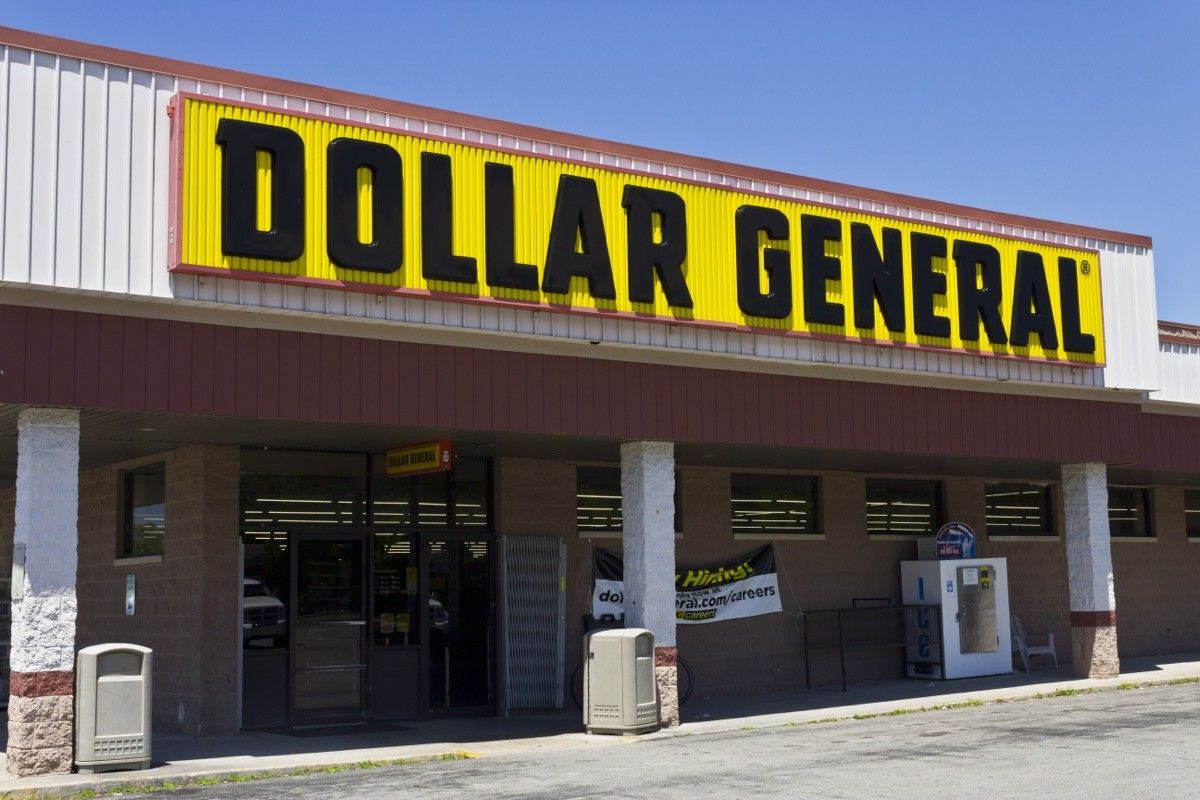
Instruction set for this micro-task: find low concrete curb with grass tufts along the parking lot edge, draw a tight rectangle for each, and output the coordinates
[0,675,1200,800]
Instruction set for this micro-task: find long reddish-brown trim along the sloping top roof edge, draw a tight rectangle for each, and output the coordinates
[0,25,1153,248]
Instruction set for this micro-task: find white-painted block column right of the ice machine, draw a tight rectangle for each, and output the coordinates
[1062,463,1121,678]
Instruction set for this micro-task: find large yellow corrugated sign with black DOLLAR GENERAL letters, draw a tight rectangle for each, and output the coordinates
[172,95,1104,365]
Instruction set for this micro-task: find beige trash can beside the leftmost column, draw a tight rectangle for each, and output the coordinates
[76,644,154,774]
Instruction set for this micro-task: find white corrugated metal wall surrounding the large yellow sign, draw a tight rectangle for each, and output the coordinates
[0,40,1176,399]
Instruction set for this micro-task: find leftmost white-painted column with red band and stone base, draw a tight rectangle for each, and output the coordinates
[8,408,79,776]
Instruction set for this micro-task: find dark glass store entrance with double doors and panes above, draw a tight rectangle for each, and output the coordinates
[241,451,498,729]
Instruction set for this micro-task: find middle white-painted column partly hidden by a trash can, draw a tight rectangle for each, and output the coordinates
[620,441,679,727]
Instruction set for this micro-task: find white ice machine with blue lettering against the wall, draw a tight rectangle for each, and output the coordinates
[900,558,1013,679]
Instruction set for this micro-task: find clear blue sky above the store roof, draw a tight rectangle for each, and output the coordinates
[9,0,1200,323]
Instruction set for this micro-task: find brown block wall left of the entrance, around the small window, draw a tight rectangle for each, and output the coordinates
[77,445,241,736]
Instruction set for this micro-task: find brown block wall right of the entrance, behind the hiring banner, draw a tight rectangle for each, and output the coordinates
[497,458,1200,696]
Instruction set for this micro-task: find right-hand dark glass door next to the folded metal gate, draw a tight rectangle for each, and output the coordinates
[424,536,494,712]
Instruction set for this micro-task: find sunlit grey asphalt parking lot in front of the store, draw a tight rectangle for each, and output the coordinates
[160,684,1200,800]
